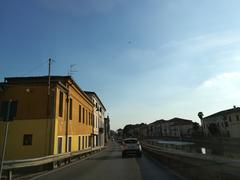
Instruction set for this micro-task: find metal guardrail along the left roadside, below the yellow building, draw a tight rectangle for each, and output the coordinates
[3,147,104,180]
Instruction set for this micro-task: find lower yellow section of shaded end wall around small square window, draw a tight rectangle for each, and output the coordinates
[0,119,49,160]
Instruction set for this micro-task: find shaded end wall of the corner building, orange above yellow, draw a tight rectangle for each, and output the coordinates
[0,84,49,160]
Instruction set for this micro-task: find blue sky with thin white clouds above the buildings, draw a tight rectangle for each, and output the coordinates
[0,0,240,129]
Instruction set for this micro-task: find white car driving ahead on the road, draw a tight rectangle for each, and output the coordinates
[122,138,142,158]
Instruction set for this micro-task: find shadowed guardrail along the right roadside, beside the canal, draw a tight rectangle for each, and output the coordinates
[142,142,240,179]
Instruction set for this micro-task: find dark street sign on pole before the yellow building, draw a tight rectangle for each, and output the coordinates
[0,101,18,122]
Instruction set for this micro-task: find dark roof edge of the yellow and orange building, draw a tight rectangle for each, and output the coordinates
[1,76,92,104]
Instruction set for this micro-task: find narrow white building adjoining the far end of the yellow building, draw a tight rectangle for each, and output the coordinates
[85,91,106,147]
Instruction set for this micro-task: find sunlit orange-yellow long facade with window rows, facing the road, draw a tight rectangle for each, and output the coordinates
[54,83,93,154]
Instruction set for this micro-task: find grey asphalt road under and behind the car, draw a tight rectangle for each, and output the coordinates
[34,143,184,180]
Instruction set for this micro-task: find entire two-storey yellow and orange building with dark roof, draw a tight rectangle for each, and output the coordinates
[0,76,94,160]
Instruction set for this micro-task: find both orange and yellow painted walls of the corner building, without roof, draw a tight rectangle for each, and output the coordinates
[0,77,93,160]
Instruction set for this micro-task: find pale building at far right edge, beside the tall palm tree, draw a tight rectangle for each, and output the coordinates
[202,106,240,138]
